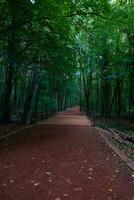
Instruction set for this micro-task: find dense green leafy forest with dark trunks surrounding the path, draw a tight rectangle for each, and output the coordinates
[0,0,134,124]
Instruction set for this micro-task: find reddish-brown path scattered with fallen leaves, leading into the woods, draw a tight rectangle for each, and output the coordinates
[0,108,134,200]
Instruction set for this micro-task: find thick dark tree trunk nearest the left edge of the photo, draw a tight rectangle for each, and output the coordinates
[1,3,16,122]
